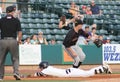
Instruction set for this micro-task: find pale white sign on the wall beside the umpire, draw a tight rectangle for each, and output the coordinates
[19,45,41,65]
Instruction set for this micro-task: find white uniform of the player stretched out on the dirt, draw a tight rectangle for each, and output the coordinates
[41,66,104,77]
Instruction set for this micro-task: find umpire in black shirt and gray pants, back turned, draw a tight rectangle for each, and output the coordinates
[0,6,22,80]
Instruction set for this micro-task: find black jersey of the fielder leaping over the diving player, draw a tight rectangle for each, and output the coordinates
[63,29,88,48]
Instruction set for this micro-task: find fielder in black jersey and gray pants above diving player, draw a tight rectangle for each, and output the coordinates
[63,20,89,68]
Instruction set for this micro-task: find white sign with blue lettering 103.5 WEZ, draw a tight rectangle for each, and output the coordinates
[102,44,120,64]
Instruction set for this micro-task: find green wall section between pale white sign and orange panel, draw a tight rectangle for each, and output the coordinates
[41,45,63,64]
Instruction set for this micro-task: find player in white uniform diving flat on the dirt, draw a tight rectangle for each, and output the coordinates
[34,62,112,77]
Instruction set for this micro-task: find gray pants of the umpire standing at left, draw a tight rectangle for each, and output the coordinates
[0,39,19,79]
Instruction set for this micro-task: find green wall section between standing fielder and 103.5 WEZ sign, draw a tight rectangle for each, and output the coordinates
[63,45,102,64]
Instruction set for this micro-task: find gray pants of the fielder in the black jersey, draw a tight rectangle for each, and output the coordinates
[66,45,86,66]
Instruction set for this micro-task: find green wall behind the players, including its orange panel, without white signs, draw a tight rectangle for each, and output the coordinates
[5,45,102,65]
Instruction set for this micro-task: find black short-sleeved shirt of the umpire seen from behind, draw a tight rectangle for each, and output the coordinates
[0,15,21,39]
